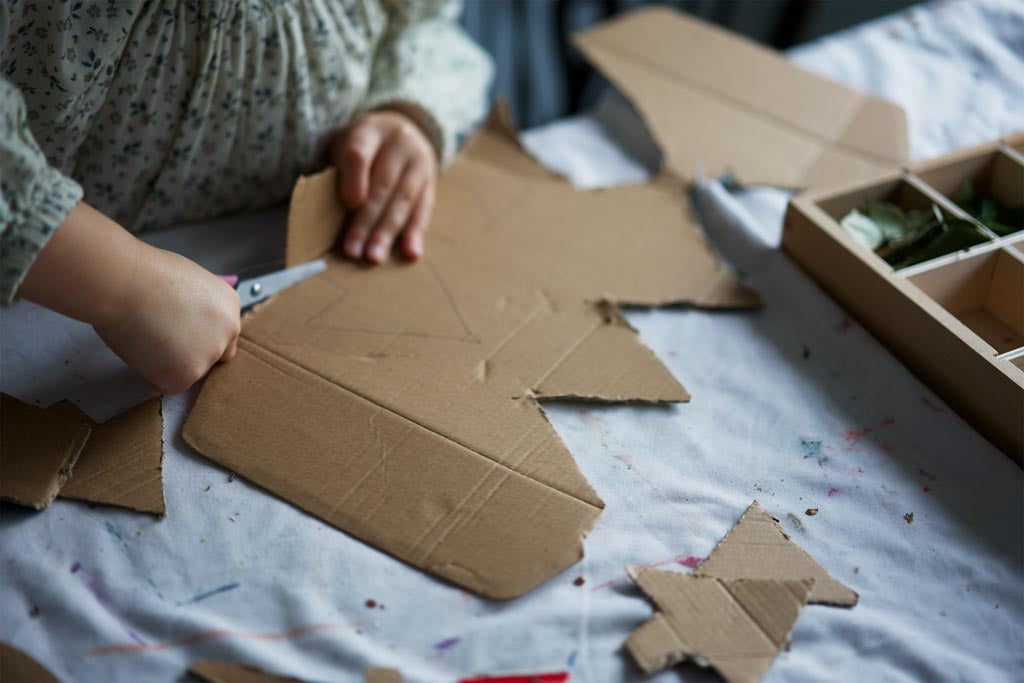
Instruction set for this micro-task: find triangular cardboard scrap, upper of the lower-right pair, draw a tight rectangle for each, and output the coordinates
[694,501,857,607]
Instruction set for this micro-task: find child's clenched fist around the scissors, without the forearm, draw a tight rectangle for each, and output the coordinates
[93,245,241,394]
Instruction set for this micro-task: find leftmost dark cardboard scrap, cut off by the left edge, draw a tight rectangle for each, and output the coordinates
[0,394,90,510]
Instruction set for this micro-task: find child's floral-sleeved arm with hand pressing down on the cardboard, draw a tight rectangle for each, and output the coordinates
[331,0,493,263]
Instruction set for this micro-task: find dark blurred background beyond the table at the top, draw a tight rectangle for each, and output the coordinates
[463,0,920,128]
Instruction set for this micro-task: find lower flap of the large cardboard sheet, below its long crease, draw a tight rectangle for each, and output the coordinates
[183,339,601,599]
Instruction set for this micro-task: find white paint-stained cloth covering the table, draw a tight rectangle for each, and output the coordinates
[0,0,1024,681]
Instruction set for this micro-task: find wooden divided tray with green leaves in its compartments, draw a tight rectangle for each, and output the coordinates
[782,133,1024,465]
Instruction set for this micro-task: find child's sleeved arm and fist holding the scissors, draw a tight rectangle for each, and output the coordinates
[0,80,239,393]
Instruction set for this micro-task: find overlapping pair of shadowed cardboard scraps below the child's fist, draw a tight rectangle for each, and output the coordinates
[0,394,164,515]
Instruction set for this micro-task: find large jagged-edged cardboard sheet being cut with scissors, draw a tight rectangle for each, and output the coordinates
[184,101,758,598]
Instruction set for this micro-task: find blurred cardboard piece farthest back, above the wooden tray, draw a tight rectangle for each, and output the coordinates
[575,8,907,187]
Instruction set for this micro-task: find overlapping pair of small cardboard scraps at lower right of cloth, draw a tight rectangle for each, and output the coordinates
[626,501,857,683]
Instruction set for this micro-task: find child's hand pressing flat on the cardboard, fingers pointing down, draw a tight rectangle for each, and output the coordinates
[331,112,437,263]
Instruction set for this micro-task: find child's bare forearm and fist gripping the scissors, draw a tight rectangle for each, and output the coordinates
[18,202,241,394]
